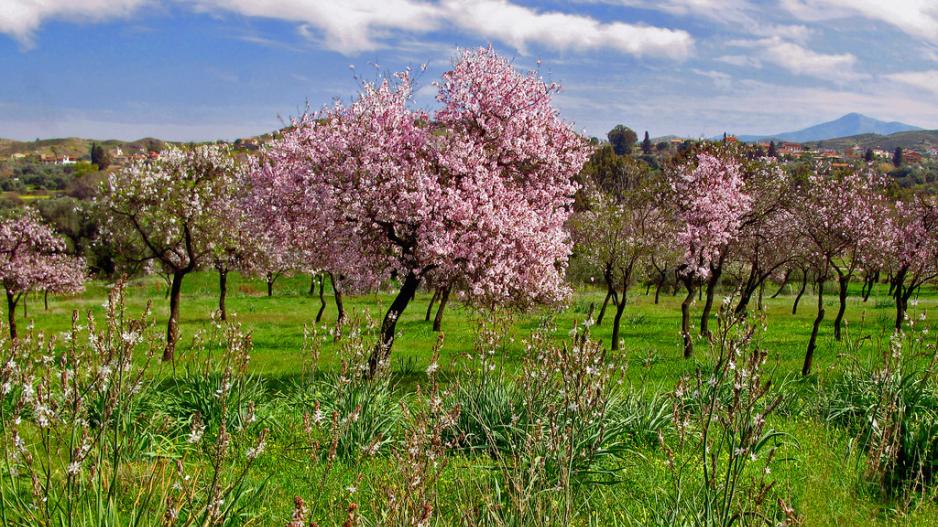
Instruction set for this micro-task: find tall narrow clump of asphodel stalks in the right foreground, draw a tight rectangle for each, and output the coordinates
[633,302,798,527]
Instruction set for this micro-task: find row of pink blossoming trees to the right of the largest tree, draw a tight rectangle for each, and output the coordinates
[572,145,938,375]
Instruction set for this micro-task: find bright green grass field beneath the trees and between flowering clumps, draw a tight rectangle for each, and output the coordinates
[12,272,938,526]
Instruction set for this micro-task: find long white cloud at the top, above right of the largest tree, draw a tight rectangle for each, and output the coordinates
[442,0,693,59]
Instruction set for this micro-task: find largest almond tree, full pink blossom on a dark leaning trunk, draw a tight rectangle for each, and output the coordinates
[249,45,589,372]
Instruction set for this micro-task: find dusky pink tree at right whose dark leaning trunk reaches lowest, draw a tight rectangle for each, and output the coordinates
[793,170,888,375]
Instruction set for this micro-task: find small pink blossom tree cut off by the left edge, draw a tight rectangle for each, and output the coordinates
[0,209,85,339]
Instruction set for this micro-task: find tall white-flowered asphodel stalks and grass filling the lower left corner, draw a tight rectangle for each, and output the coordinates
[0,283,266,526]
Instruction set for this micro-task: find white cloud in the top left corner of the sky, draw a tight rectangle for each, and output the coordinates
[0,0,149,46]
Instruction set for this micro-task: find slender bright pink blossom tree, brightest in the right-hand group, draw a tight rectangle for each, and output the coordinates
[669,153,752,358]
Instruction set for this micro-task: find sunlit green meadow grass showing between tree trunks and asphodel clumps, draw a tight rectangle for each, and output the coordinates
[7,272,938,526]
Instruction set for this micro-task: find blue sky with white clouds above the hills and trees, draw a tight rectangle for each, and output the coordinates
[0,0,938,140]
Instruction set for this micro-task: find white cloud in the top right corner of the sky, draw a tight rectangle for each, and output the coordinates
[782,0,938,42]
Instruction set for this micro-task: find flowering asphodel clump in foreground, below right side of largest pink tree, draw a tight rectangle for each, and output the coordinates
[457,316,629,525]
